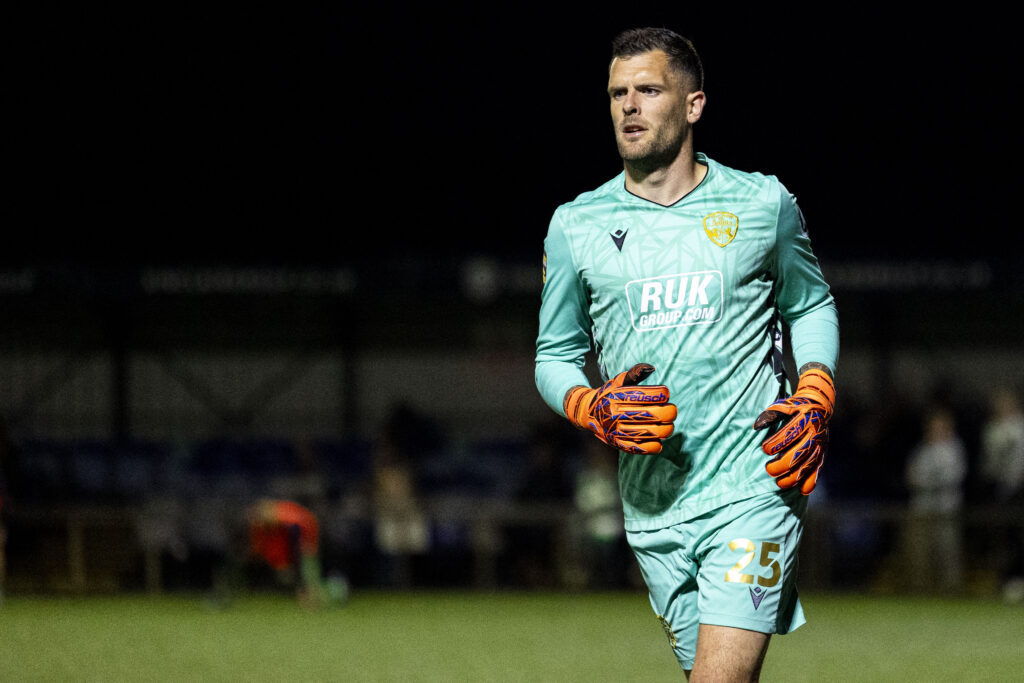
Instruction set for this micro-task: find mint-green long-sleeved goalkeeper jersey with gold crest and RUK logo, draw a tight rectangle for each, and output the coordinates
[536,155,839,530]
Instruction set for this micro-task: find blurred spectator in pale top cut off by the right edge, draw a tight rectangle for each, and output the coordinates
[981,387,1024,601]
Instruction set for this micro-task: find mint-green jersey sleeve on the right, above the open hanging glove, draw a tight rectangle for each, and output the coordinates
[774,187,839,374]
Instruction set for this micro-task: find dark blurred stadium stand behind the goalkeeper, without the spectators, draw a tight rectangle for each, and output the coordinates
[0,258,1024,592]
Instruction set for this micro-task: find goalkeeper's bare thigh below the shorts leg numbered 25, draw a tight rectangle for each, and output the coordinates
[687,624,771,683]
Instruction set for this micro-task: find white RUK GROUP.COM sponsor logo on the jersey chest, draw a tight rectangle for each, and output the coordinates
[626,270,723,332]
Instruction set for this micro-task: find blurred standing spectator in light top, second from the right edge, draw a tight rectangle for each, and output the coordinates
[905,407,967,592]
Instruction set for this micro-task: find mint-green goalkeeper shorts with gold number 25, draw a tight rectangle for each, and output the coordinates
[627,492,807,670]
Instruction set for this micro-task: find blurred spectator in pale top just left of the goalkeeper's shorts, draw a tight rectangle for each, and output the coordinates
[573,438,632,589]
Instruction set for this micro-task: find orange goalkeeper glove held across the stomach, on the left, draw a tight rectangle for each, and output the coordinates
[562,362,676,455]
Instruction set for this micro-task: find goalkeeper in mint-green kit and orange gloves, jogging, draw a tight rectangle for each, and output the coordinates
[537,29,839,681]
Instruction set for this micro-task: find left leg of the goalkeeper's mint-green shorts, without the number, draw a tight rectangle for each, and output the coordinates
[627,525,699,671]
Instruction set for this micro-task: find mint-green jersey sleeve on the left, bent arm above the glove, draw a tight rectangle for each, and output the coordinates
[535,211,591,416]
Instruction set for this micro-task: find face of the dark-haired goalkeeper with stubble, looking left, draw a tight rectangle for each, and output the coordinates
[608,50,703,166]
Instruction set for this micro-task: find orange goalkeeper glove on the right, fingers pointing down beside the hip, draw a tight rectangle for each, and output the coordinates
[754,370,836,496]
